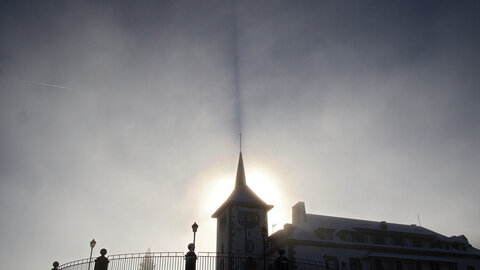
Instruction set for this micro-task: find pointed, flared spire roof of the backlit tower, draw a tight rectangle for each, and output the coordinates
[212,152,273,218]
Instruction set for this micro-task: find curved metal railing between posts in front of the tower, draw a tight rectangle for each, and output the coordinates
[58,252,326,270]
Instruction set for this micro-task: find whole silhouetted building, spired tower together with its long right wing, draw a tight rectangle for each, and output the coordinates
[212,153,480,270]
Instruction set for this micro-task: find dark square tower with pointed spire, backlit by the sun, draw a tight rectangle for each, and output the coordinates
[212,152,273,256]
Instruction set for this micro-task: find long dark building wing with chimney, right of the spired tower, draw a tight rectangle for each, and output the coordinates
[269,202,480,270]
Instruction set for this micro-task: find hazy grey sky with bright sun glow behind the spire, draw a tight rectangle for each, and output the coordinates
[0,0,480,270]
